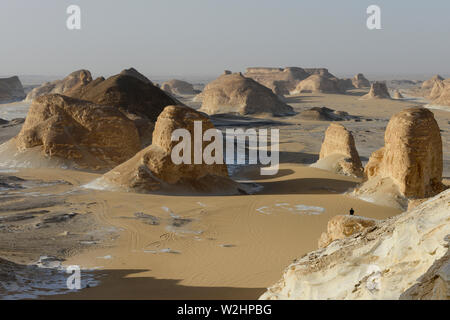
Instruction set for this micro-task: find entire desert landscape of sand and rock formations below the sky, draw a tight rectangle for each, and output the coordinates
[0,67,450,299]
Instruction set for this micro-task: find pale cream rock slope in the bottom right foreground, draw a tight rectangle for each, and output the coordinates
[260,190,450,300]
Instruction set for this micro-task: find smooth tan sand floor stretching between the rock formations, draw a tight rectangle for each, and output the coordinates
[0,90,450,299]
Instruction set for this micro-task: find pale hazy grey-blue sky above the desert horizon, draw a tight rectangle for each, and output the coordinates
[0,0,450,76]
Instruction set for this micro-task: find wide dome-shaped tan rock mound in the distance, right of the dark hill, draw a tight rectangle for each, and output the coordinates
[196,73,293,116]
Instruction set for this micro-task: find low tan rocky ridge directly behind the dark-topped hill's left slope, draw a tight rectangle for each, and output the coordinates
[26,70,92,101]
